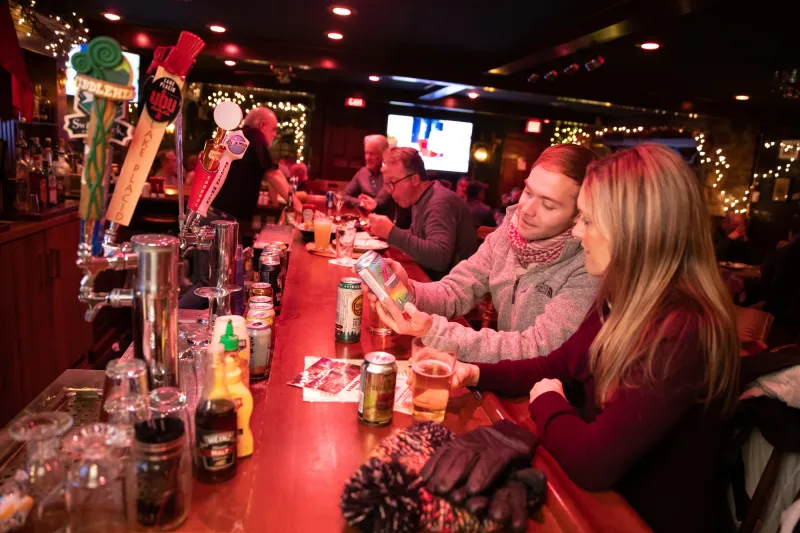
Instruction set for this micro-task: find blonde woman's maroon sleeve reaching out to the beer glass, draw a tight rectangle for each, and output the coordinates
[468,310,601,396]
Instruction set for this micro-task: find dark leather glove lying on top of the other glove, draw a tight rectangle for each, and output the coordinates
[420,420,539,503]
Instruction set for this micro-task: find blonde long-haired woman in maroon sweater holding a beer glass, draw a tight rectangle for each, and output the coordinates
[446,144,738,532]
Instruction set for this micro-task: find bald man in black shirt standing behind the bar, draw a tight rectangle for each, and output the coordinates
[212,107,303,221]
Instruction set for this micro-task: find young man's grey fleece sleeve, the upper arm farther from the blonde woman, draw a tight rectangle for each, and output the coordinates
[410,228,495,319]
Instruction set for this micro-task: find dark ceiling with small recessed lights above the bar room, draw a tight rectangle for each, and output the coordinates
[34,0,800,122]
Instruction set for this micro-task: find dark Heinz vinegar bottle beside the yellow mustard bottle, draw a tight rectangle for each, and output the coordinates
[194,342,238,483]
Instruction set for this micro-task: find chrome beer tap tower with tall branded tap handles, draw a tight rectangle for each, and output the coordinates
[72,32,247,388]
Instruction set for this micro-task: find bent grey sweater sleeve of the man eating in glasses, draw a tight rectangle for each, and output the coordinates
[387,196,458,272]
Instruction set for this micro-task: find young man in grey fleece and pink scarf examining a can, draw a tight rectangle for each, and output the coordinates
[367,144,599,362]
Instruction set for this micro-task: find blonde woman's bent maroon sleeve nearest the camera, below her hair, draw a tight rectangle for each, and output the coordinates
[529,320,704,490]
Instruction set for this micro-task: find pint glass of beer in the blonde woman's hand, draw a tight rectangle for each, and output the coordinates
[411,337,458,422]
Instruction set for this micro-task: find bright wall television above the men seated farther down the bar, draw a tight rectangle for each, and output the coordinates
[386,115,472,172]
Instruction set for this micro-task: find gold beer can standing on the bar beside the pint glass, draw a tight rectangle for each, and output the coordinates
[358,352,397,426]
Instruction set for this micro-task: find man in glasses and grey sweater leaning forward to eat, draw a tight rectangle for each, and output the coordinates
[369,147,478,279]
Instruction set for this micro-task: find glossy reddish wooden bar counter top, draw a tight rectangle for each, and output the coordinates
[180,231,648,532]
